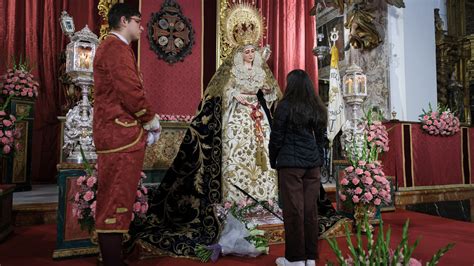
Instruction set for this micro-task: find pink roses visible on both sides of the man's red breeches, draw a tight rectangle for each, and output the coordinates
[72,164,148,231]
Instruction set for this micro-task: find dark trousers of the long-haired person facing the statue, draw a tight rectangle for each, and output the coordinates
[278,167,320,261]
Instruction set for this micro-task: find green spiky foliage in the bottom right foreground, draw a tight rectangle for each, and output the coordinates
[327,215,455,266]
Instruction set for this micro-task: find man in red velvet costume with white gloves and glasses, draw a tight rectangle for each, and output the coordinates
[93,4,160,266]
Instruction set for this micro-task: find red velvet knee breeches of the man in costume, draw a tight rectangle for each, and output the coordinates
[95,149,145,233]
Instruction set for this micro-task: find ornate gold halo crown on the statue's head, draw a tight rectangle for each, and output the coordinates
[225,3,264,47]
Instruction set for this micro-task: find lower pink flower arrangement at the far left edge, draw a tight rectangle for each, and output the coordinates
[0,110,21,155]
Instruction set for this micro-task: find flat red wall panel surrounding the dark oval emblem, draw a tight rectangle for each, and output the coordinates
[139,0,202,115]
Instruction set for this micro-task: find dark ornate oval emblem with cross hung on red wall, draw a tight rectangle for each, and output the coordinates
[148,0,195,64]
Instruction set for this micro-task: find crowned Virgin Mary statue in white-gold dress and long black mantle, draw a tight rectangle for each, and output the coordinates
[126,4,346,257]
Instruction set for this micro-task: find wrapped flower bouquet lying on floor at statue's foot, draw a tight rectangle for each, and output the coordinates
[195,199,281,262]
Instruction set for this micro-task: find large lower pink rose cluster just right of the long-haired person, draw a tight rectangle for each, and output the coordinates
[339,161,392,206]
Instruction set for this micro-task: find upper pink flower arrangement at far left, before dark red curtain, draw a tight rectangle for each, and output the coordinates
[1,69,39,98]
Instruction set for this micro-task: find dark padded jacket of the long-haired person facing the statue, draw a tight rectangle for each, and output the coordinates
[269,101,325,169]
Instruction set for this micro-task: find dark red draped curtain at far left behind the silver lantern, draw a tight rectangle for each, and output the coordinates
[0,0,100,182]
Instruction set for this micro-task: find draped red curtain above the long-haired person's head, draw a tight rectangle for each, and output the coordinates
[257,0,318,92]
